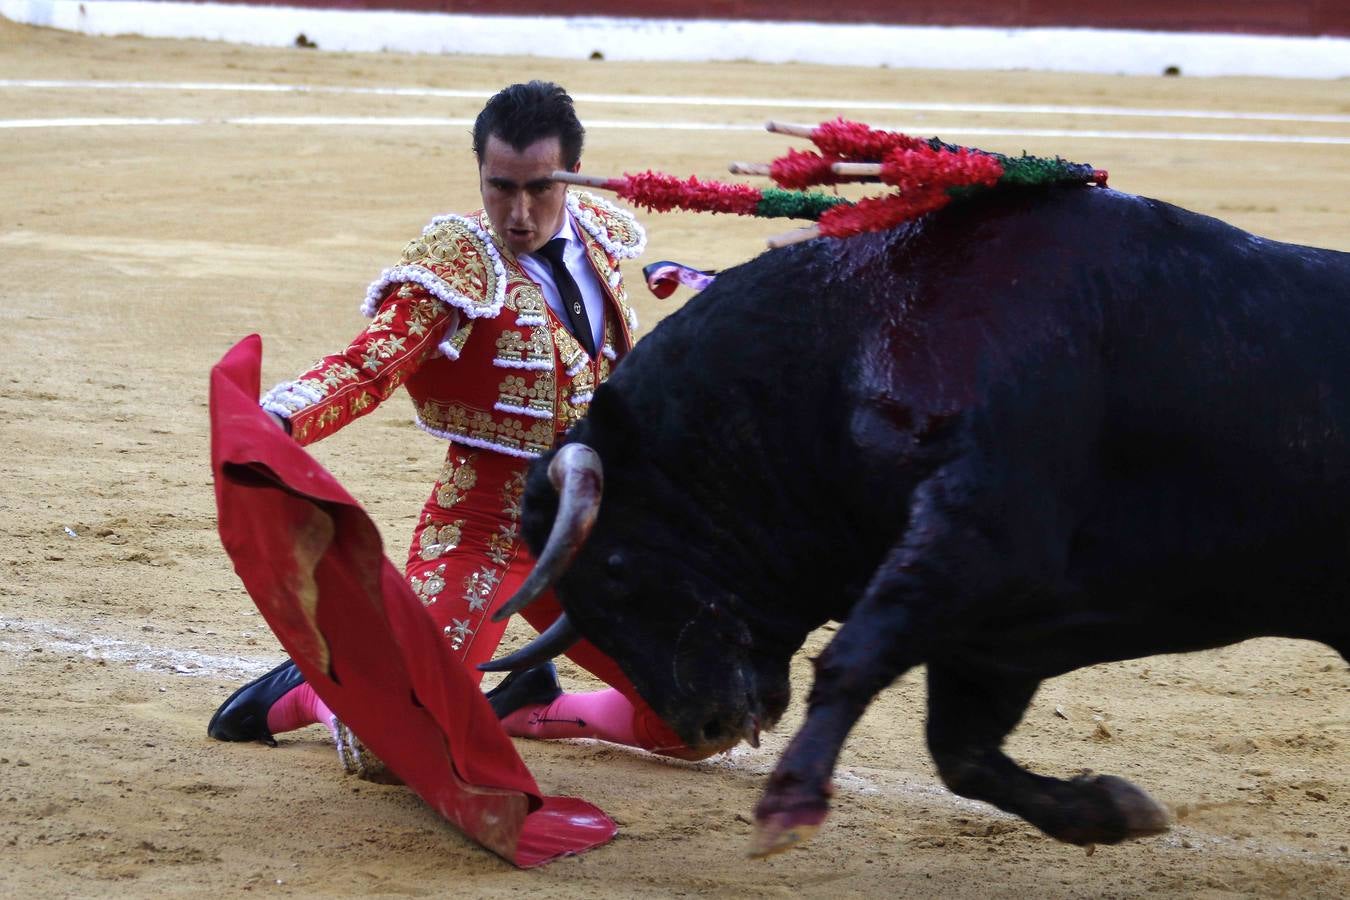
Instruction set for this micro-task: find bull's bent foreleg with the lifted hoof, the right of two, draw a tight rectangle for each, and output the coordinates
[927,663,1168,843]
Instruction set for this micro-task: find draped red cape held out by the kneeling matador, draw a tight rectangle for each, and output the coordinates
[211,335,616,868]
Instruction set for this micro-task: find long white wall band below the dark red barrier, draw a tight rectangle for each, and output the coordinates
[0,0,1350,78]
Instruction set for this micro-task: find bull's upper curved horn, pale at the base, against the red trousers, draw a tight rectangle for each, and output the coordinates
[493,444,605,622]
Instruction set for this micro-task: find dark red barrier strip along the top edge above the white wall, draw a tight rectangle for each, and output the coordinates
[195,0,1350,36]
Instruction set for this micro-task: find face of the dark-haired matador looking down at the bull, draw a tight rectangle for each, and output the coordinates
[478,135,581,256]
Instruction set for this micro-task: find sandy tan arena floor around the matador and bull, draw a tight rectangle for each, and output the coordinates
[0,15,1350,899]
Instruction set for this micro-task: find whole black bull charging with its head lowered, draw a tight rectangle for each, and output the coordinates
[488,188,1350,851]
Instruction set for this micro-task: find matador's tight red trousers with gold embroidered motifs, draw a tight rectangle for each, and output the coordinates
[405,444,697,758]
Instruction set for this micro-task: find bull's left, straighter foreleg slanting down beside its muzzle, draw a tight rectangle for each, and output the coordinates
[751,568,917,855]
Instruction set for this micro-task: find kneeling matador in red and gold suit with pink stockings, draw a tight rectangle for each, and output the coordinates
[208,81,687,761]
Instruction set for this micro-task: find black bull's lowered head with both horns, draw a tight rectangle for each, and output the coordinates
[482,386,799,753]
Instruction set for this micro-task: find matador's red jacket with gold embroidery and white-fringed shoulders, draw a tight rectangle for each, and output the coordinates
[262,192,647,457]
